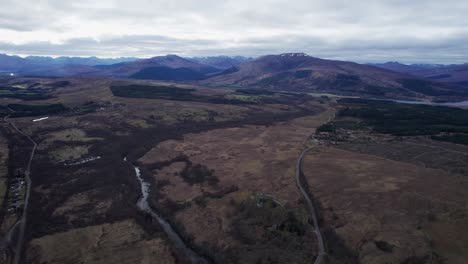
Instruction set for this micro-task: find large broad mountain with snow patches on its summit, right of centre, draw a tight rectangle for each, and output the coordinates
[203,53,468,100]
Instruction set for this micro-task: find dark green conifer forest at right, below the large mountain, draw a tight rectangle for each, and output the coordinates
[332,98,468,144]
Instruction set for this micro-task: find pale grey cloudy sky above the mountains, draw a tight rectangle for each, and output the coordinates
[0,0,468,63]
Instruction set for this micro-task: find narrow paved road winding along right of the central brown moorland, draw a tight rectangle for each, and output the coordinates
[296,148,325,264]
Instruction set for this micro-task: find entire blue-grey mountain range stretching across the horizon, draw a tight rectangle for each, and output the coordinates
[0,53,468,100]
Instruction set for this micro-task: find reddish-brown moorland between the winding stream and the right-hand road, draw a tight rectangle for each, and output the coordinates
[140,111,332,263]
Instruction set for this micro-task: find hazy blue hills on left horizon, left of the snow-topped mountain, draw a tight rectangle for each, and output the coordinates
[0,54,216,81]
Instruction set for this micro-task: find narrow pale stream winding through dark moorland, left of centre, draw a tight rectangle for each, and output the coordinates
[131,165,208,264]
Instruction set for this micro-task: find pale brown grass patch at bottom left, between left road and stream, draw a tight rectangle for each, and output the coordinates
[28,220,176,264]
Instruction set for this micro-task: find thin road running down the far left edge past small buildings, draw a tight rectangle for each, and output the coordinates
[3,116,37,264]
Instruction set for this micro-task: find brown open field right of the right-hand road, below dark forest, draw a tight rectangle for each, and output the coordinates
[304,146,468,264]
